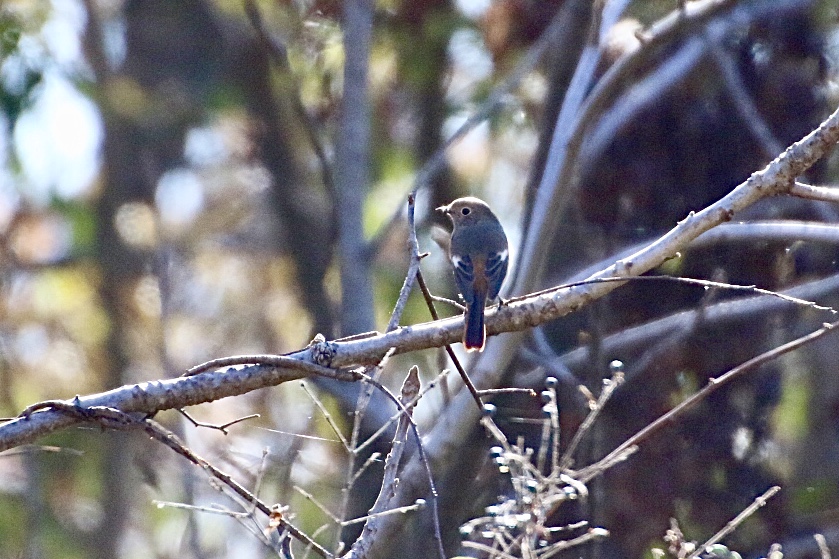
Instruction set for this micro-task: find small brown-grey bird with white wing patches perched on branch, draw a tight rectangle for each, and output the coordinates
[437,196,509,351]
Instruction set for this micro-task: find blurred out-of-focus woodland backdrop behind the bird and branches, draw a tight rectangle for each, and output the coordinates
[0,0,839,558]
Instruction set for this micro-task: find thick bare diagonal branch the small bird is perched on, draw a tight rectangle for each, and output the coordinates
[0,101,839,485]
